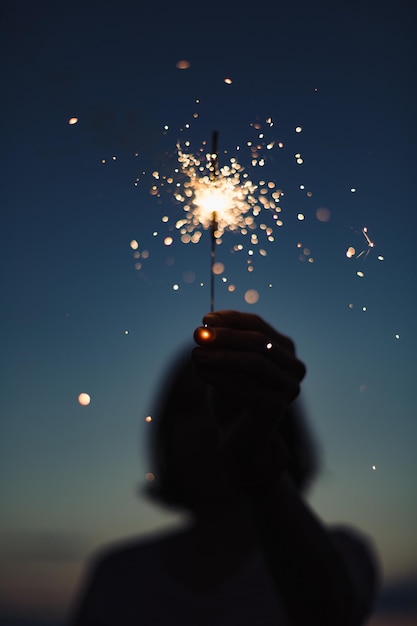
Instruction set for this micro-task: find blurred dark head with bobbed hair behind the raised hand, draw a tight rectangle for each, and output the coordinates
[145,347,318,512]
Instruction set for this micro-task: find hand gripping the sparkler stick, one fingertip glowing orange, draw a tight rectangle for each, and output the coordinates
[193,311,306,480]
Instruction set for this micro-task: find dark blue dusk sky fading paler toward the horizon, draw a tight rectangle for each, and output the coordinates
[0,0,417,615]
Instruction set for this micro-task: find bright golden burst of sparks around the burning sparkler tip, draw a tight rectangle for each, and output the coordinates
[131,117,324,306]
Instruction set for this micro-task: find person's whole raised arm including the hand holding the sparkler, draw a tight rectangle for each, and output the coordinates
[193,311,376,626]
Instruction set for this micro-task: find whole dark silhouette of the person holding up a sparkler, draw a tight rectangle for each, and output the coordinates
[71,311,379,626]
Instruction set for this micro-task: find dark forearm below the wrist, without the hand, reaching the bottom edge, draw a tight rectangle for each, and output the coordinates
[245,473,374,626]
